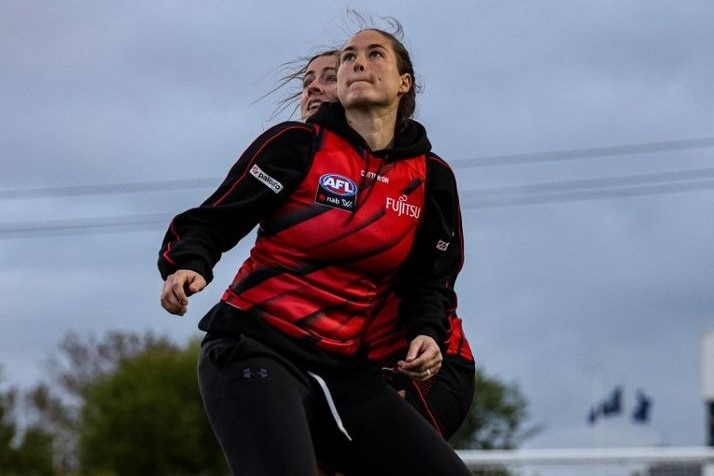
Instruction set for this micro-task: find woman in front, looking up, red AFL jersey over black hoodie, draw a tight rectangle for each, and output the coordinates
[159,23,470,476]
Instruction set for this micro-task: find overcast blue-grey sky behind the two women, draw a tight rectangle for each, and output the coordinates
[0,0,714,447]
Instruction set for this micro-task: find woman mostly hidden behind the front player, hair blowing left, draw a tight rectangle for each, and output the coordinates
[298,50,476,439]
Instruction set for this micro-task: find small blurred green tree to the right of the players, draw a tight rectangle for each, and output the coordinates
[449,369,539,449]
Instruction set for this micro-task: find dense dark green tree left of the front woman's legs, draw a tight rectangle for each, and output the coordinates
[79,341,227,476]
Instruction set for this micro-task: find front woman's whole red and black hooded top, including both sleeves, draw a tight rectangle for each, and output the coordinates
[159,103,463,370]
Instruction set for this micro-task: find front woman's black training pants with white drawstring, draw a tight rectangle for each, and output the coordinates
[198,336,471,476]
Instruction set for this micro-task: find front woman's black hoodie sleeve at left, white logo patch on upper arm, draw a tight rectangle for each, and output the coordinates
[158,122,313,282]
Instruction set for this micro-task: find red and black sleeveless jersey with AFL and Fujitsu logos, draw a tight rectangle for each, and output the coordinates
[223,129,426,354]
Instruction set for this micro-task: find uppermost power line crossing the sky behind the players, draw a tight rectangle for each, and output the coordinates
[0,137,714,200]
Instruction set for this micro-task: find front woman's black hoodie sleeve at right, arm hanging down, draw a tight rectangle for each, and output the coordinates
[397,155,464,345]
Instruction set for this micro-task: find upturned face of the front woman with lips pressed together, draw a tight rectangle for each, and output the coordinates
[337,30,412,109]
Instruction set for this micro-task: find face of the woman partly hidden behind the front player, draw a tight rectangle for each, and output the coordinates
[300,55,337,121]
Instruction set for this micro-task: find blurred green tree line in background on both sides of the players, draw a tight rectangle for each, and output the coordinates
[0,332,535,476]
